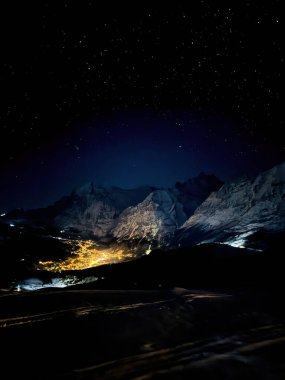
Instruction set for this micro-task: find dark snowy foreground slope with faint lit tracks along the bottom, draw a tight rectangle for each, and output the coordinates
[0,288,285,380]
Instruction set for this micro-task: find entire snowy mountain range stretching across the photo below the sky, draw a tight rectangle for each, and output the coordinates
[1,162,285,253]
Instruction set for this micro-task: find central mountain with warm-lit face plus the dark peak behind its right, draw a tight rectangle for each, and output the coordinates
[112,173,223,248]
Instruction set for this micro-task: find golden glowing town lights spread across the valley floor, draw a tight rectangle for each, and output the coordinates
[37,240,133,272]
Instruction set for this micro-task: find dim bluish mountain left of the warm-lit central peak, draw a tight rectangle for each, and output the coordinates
[1,183,154,239]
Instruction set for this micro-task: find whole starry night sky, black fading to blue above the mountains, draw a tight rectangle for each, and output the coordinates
[0,0,285,212]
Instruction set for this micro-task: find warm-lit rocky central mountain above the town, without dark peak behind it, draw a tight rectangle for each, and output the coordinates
[113,190,187,248]
